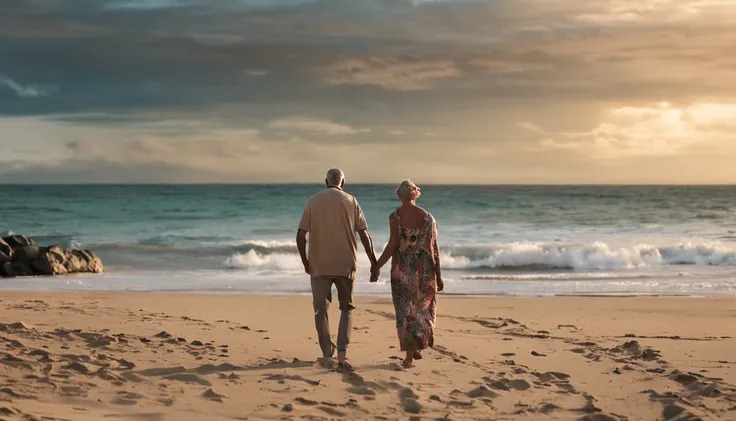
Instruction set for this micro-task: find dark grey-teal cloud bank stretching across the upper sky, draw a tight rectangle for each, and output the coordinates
[0,0,730,115]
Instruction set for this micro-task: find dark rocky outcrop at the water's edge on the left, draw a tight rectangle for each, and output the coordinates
[0,235,105,277]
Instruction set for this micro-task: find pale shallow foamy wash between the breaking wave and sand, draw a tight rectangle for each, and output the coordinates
[0,262,736,297]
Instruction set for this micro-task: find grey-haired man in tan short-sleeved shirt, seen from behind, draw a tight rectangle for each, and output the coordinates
[296,168,376,367]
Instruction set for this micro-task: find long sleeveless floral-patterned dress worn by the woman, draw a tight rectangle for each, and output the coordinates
[390,210,439,351]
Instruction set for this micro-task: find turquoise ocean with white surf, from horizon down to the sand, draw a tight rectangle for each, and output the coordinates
[0,185,736,295]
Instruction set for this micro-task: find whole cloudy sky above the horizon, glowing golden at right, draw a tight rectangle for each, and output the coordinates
[0,0,736,184]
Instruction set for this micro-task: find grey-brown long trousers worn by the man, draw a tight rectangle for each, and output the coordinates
[312,276,355,357]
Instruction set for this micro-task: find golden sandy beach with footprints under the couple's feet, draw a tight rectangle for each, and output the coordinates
[0,292,736,421]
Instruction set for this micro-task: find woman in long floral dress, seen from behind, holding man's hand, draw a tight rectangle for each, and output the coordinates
[371,180,444,368]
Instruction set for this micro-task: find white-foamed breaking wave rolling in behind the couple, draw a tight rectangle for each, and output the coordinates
[10,231,736,272]
